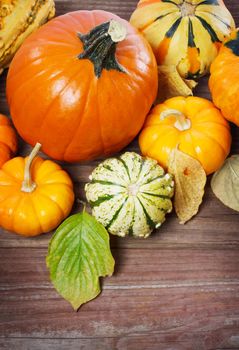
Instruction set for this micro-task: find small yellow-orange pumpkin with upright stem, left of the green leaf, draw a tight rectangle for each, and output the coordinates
[0,144,74,236]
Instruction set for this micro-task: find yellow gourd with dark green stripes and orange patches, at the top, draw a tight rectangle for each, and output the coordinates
[131,0,235,79]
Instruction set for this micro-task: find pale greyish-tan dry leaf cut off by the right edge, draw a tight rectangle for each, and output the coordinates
[211,155,239,211]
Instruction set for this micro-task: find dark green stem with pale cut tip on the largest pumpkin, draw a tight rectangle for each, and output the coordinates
[77,20,127,78]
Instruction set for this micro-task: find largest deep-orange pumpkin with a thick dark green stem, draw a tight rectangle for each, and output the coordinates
[7,11,158,162]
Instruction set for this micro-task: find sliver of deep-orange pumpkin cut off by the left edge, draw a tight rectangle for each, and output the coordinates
[0,114,17,168]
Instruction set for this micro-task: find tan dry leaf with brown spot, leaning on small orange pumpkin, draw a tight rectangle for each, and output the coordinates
[168,149,207,224]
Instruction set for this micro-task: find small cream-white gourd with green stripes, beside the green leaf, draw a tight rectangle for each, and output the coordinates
[85,152,174,238]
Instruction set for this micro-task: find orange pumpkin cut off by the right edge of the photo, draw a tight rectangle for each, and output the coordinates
[209,31,239,126]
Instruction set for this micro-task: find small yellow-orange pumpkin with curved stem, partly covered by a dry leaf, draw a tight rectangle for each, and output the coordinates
[139,96,231,174]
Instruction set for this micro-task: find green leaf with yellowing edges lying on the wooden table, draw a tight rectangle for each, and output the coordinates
[46,212,115,310]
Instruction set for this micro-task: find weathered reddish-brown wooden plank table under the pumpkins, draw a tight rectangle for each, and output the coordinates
[0,0,239,350]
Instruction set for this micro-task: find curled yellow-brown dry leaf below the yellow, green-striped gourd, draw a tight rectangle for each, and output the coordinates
[157,65,197,103]
